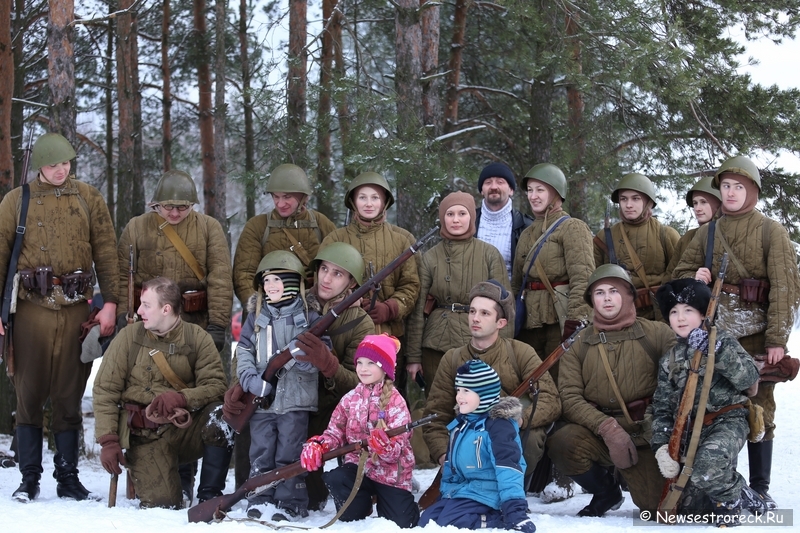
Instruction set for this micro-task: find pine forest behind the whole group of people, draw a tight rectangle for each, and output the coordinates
[0,0,800,432]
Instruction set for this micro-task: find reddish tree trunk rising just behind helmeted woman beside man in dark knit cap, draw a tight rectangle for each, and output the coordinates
[565,7,588,220]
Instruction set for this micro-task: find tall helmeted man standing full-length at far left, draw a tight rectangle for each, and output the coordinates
[0,133,119,502]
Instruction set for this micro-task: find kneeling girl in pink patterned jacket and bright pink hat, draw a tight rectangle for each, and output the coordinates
[300,333,419,528]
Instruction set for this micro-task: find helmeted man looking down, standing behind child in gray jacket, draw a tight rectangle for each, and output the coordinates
[233,163,336,306]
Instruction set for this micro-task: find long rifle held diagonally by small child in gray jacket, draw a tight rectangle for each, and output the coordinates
[223,227,439,433]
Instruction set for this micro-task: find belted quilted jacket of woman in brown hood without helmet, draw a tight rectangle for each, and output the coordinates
[406,237,514,363]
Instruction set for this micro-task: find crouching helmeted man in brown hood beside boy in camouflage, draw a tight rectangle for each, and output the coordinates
[547,265,675,516]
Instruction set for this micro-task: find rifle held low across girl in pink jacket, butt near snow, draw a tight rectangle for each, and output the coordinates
[189,414,438,522]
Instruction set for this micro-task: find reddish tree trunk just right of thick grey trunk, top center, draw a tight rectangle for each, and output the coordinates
[419,0,442,137]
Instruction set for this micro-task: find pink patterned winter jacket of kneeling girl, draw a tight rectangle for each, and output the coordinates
[321,381,414,491]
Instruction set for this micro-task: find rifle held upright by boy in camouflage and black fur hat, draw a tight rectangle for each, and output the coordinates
[658,252,728,514]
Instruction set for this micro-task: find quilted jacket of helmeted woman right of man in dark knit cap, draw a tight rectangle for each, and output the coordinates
[511,211,594,329]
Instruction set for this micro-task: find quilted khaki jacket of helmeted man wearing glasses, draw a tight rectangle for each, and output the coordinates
[117,211,233,328]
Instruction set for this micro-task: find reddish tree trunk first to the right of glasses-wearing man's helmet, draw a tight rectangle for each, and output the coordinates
[194,0,216,217]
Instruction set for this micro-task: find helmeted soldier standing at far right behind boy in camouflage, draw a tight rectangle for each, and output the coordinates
[673,155,800,508]
